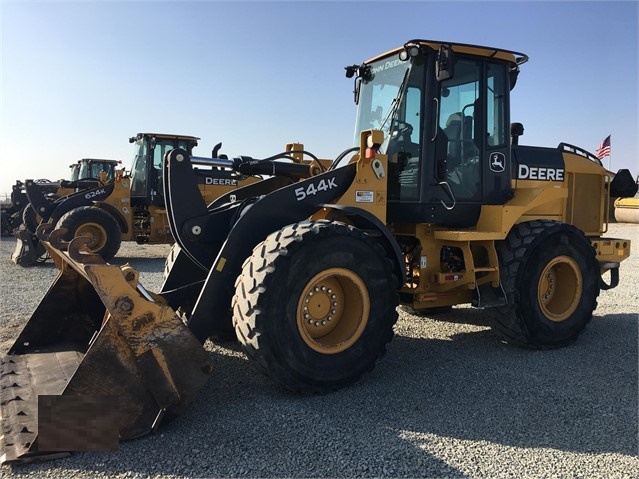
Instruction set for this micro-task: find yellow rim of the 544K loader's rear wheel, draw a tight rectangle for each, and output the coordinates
[537,256,583,322]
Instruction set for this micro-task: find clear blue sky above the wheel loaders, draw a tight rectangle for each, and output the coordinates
[0,0,639,193]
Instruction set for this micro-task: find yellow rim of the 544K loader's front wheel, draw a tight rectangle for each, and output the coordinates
[297,268,370,354]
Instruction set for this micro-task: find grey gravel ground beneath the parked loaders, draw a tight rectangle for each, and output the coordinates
[0,224,639,478]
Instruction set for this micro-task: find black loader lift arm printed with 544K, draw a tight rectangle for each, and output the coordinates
[187,163,356,343]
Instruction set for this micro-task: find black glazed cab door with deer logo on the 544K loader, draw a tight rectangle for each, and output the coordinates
[424,55,512,227]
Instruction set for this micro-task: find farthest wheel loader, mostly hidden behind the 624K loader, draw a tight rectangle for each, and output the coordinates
[2,158,120,236]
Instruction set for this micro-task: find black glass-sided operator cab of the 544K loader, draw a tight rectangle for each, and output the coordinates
[347,40,527,227]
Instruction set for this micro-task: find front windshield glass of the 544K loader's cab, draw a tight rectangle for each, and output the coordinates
[355,57,422,153]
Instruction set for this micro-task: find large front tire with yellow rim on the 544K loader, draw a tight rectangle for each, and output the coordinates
[233,221,399,393]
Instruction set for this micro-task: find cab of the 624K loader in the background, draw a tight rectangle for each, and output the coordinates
[129,133,199,206]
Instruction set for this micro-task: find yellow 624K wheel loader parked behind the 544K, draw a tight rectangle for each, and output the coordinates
[12,133,259,266]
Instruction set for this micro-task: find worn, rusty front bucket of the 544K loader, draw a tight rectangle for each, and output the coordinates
[0,227,212,463]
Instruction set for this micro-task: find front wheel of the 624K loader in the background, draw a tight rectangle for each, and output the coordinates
[56,206,122,261]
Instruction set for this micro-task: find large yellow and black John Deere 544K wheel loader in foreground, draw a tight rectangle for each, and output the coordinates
[2,40,630,462]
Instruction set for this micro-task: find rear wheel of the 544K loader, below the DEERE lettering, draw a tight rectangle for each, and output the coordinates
[493,220,599,349]
